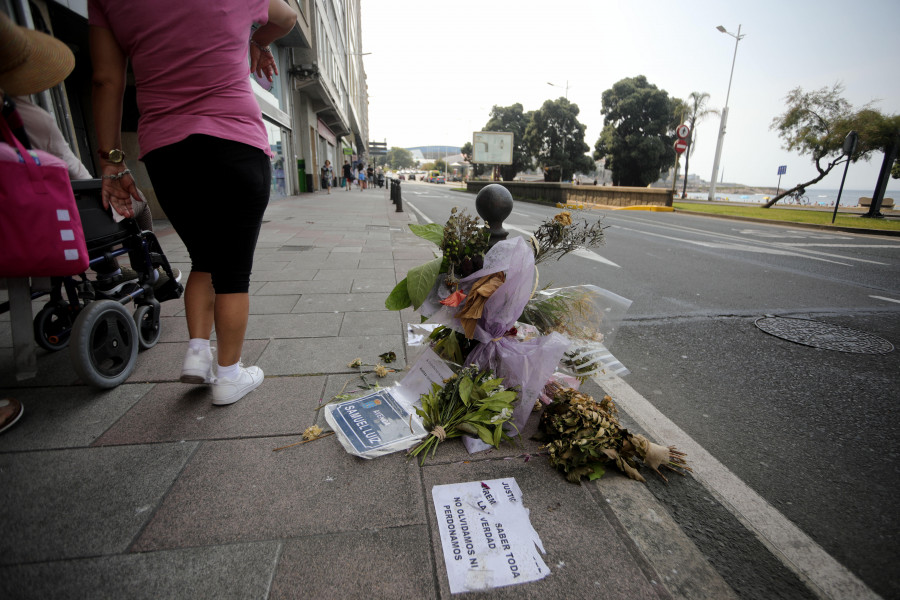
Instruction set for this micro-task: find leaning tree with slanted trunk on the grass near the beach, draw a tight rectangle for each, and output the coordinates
[763,83,900,208]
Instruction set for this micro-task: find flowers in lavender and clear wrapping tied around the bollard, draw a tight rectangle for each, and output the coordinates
[385,208,629,453]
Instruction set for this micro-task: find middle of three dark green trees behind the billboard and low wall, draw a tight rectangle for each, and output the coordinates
[525,97,594,181]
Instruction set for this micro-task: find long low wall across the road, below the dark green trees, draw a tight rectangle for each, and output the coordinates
[466,181,672,208]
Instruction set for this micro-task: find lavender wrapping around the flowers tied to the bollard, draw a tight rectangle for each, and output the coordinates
[429,238,571,452]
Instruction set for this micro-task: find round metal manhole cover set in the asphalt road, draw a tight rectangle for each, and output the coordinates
[756,317,894,354]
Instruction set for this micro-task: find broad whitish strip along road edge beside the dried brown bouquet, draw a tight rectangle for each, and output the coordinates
[597,376,878,599]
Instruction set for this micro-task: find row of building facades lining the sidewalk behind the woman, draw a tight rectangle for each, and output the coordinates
[0,0,368,209]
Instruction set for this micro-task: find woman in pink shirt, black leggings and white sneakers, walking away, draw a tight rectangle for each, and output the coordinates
[88,0,297,405]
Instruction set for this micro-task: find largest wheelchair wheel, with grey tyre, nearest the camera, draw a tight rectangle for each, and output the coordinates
[70,300,138,388]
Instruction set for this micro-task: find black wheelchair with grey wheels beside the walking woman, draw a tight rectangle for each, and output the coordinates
[32,179,184,388]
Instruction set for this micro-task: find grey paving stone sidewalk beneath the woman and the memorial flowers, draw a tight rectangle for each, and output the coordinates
[0,189,732,599]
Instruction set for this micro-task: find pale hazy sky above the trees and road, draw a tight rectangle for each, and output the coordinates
[362,0,900,191]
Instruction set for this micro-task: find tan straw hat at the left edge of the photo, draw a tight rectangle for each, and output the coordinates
[0,12,75,96]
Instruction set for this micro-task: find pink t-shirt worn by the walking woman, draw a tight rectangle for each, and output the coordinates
[88,0,272,157]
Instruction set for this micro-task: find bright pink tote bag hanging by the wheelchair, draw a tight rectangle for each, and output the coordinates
[0,116,89,277]
